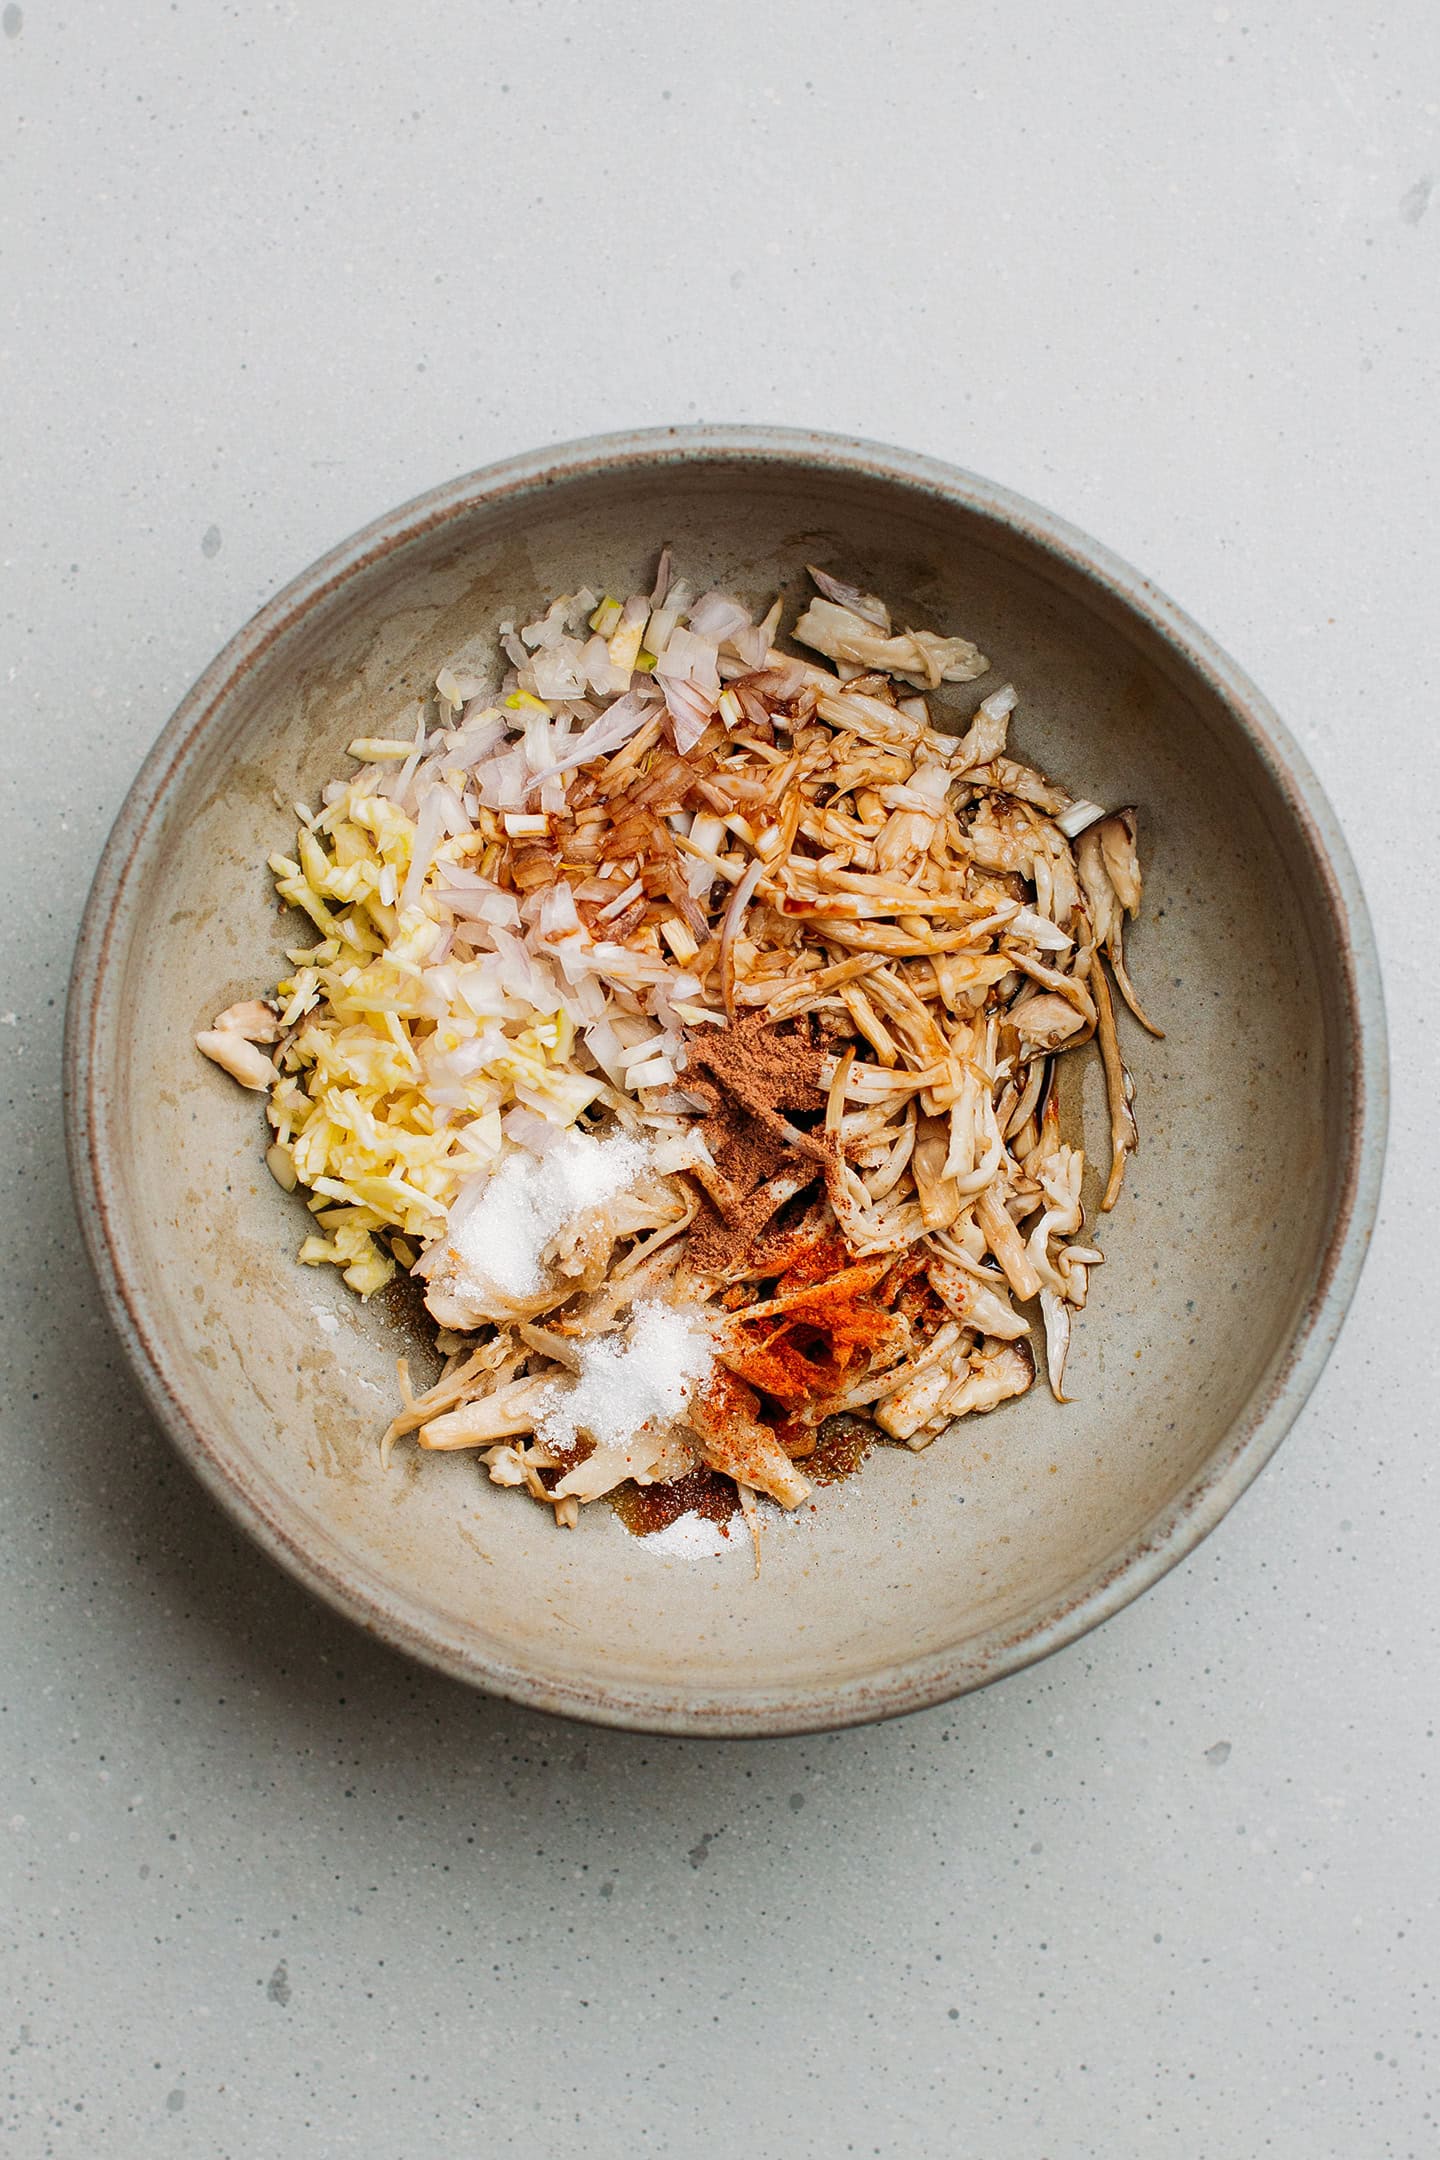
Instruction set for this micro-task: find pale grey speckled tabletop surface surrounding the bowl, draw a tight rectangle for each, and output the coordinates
[0,0,1440,2160]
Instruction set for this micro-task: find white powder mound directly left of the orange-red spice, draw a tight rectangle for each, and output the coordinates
[535,1305,710,1449]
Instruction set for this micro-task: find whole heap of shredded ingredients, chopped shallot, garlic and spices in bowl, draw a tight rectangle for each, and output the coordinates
[196,551,1159,1527]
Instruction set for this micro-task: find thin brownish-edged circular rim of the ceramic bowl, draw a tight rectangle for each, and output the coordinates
[65,426,1388,1737]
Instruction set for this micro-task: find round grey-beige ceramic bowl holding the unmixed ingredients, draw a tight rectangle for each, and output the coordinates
[67,428,1386,1734]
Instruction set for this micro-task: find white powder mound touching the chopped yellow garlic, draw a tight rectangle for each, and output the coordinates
[449,1132,650,1305]
